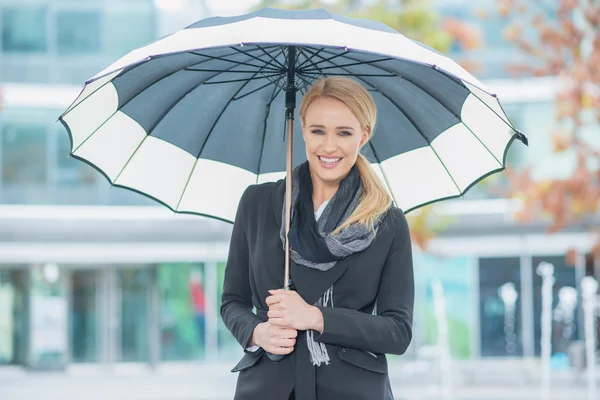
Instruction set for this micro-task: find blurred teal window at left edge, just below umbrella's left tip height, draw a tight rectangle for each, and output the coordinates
[0,123,47,184]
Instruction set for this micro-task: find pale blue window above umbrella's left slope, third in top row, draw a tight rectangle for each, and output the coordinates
[105,9,156,57]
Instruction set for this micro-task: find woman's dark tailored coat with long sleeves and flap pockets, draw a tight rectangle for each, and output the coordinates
[221,180,414,400]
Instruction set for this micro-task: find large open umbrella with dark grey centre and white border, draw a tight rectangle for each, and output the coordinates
[59,8,527,225]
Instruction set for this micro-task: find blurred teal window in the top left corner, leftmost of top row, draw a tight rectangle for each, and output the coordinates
[2,7,47,53]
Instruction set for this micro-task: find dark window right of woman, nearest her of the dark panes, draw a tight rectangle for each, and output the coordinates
[479,257,523,356]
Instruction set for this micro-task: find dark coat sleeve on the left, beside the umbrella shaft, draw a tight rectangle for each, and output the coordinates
[221,187,263,350]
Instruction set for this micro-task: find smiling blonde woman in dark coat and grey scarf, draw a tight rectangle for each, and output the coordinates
[221,77,414,400]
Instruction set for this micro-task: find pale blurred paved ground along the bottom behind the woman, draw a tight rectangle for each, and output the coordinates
[0,361,600,400]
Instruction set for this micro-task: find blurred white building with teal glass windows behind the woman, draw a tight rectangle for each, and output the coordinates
[0,0,598,371]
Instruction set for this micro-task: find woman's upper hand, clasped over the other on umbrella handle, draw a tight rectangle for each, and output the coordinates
[266,289,323,332]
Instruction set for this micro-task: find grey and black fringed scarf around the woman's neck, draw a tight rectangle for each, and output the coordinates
[280,162,381,366]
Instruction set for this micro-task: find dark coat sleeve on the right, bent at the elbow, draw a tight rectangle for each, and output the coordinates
[315,210,414,354]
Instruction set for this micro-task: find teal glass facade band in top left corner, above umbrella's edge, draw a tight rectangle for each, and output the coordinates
[0,0,158,85]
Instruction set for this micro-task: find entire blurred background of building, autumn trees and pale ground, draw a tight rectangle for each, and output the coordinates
[0,0,600,400]
